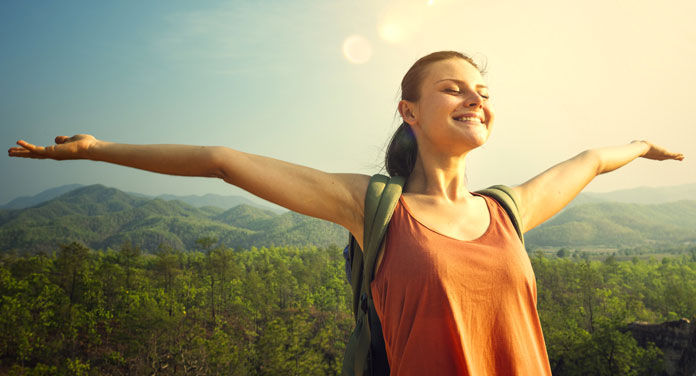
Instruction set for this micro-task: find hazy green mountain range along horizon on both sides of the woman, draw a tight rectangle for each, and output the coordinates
[0,184,696,252]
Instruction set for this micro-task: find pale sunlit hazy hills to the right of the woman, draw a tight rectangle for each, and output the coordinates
[525,201,696,249]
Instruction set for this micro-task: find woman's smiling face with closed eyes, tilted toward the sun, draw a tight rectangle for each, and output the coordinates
[402,58,494,155]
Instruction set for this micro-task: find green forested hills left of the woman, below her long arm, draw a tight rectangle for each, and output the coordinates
[0,185,348,252]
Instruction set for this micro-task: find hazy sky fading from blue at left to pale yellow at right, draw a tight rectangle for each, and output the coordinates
[0,0,696,204]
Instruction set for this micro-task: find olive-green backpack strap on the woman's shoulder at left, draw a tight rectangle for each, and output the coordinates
[343,174,405,375]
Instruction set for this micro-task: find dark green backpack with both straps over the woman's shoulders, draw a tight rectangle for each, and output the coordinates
[342,174,524,376]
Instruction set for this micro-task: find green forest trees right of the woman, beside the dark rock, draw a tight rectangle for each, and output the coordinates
[532,254,696,375]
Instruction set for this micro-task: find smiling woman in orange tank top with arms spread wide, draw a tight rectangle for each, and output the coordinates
[9,51,684,375]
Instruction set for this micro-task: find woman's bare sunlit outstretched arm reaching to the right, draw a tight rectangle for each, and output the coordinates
[513,141,684,232]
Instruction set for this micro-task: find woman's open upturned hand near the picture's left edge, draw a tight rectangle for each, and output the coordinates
[8,134,97,161]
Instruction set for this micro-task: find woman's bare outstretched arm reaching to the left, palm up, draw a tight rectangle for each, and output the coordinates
[8,135,369,244]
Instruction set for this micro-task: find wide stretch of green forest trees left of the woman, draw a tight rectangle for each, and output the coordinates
[0,242,352,375]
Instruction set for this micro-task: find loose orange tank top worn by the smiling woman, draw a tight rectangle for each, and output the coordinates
[371,196,551,376]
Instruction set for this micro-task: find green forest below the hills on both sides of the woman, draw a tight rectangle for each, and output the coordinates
[0,241,696,375]
